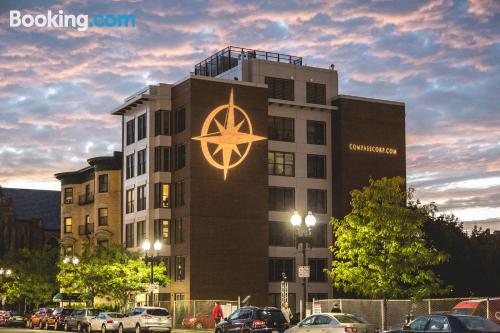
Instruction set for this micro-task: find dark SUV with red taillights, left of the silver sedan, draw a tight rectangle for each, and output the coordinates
[215,306,288,333]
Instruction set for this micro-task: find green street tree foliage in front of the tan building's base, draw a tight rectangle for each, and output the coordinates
[57,245,170,306]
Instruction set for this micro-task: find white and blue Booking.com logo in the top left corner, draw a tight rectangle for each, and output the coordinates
[10,10,136,31]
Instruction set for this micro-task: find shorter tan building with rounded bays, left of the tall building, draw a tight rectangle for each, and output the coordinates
[55,152,122,256]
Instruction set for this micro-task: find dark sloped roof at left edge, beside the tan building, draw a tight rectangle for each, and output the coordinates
[1,187,61,230]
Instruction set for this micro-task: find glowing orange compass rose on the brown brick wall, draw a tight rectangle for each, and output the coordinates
[192,88,266,180]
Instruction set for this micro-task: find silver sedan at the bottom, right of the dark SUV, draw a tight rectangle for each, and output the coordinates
[286,313,379,333]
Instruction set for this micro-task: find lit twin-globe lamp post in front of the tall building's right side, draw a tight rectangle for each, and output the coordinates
[290,211,316,316]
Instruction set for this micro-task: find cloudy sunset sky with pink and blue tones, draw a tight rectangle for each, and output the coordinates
[0,0,500,229]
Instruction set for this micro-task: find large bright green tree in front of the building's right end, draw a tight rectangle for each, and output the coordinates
[328,177,447,299]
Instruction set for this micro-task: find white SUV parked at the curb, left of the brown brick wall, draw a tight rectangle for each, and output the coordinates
[118,306,172,333]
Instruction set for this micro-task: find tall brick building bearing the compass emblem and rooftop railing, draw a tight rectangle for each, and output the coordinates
[113,47,406,309]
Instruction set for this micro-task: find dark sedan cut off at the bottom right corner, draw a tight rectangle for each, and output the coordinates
[390,314,500,333]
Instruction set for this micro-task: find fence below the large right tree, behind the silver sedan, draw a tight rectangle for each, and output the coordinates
[307,297,500,330]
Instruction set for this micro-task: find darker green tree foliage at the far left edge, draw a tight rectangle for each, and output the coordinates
[0,249,59,306]
